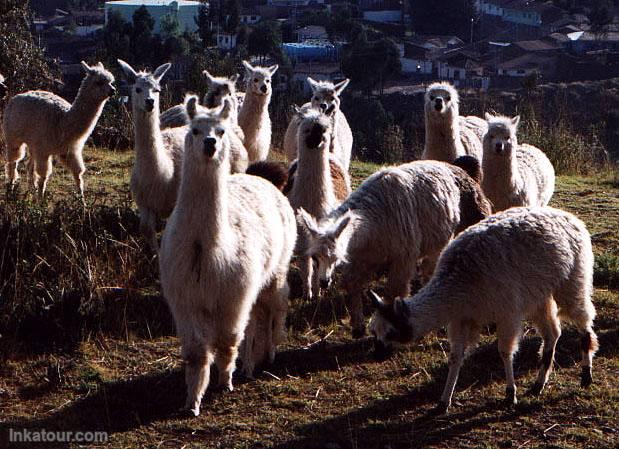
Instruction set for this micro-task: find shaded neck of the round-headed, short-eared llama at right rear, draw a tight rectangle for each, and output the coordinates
[425,113,464,162]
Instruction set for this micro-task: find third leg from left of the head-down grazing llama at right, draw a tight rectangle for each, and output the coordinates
[531,299,561,396]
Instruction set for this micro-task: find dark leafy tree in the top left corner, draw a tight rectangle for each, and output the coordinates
[0,0,58,92]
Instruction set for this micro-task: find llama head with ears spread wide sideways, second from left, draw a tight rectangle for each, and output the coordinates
[118,59,172,114]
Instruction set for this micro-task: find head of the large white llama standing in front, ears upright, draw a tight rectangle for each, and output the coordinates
[185,95,233,166]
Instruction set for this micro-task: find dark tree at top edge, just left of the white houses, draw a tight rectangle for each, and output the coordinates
[409,0,477,41]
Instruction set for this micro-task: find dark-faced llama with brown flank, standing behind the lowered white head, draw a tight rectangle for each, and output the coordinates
[288,109,350,299]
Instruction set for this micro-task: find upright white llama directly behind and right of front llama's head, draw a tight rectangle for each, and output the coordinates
[239,61,279,162]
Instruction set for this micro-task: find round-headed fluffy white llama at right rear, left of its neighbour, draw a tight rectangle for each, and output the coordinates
[421,83,486,162]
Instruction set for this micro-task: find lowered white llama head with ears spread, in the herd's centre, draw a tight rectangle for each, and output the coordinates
[297,208,356,289]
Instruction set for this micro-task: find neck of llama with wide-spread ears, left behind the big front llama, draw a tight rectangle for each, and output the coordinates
[133,106,172,170]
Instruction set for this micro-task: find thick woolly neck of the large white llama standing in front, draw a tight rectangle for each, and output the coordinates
[176,156,231,248]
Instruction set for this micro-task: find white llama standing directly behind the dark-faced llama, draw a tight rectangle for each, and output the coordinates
[284,77,353,170]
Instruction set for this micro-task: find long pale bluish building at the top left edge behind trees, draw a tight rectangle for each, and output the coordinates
[105,0,202,33]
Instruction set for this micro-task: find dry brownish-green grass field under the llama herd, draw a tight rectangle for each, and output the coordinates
[0,150,619,449]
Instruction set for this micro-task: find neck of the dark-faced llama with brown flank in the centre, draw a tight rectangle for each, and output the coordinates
[295,142,337,219]
